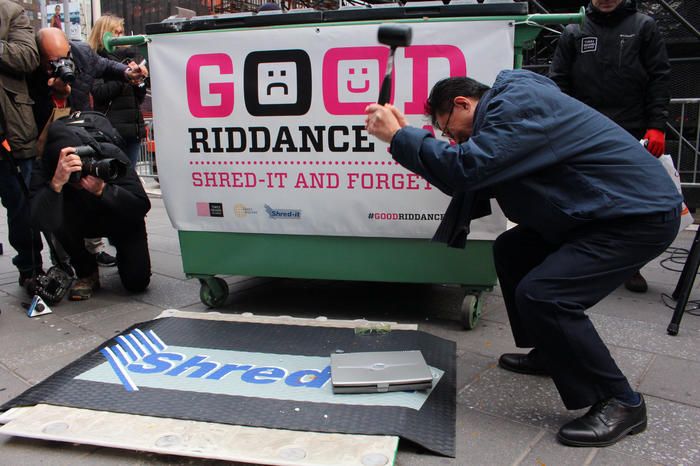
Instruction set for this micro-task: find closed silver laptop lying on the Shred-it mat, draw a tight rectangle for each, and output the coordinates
[331,350,433,393]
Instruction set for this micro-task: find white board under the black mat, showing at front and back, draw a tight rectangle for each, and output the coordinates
[0,309,408,466]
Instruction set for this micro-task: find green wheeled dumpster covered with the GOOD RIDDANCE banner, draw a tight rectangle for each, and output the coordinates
[117,2,583,328]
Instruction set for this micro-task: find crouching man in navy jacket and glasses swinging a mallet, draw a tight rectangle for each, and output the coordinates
[366,70,681,447]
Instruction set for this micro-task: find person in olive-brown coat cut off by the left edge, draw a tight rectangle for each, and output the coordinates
[0,0,42,286]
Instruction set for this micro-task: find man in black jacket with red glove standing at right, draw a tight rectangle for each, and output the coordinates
[550,0,671,292]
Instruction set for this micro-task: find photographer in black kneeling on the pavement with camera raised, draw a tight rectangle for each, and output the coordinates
[30,119,151,301]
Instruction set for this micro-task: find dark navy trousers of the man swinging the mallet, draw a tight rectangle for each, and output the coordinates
[494,208,680,409]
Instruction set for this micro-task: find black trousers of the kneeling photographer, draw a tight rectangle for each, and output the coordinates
[54,204,151,292]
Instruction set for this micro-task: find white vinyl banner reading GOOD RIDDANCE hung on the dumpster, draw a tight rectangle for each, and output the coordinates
[149,20,514,239]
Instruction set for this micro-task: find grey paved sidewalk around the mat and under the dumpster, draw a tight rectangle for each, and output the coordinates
[0,190,700,466]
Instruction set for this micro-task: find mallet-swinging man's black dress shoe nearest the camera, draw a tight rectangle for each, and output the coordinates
[557,395,647,447]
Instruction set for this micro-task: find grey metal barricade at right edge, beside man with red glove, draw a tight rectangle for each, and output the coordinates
[666,98,700,189]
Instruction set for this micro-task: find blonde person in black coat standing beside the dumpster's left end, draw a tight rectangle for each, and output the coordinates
[88,15,148,166]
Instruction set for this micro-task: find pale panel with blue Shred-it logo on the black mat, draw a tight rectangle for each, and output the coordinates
[85,329,443,409]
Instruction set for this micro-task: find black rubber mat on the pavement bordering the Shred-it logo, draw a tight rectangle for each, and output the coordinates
[0,317,456,457]
